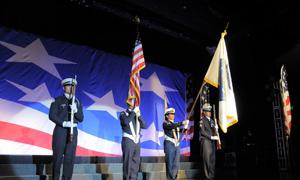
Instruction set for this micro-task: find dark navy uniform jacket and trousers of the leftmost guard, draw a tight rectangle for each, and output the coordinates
[49,96,83,180]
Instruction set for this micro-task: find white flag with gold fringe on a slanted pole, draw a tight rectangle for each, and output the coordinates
[204,31,238,133]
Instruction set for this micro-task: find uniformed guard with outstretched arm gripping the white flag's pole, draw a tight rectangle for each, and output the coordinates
[163,108,189,180]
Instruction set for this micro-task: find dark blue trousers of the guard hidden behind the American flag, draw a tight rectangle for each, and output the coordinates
[122,137,141,180]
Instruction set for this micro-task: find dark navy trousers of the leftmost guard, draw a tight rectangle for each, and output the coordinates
[52,127,78,180]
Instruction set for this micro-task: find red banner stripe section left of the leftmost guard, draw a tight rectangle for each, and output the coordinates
[0,121,52,150]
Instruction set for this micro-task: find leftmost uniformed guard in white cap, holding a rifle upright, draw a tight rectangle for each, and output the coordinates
[49,78,83,180]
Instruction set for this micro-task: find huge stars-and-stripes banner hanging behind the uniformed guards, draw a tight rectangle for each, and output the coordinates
[0,26,190,156]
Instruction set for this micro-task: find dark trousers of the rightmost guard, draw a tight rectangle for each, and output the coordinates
[201,138,216,179]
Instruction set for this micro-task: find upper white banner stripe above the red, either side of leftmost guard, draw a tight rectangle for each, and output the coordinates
[0,98,122,154]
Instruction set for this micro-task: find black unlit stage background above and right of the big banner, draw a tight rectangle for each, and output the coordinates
[0,0,300,179]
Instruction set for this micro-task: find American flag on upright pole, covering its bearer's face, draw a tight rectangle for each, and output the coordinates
[128,38,146,106]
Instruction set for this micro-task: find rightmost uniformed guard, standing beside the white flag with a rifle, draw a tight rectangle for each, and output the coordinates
[200,103,218,180]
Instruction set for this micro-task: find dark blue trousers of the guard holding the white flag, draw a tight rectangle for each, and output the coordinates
[164,140,180,180]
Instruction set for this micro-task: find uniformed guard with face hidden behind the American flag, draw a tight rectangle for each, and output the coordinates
[120,96,146,180]
